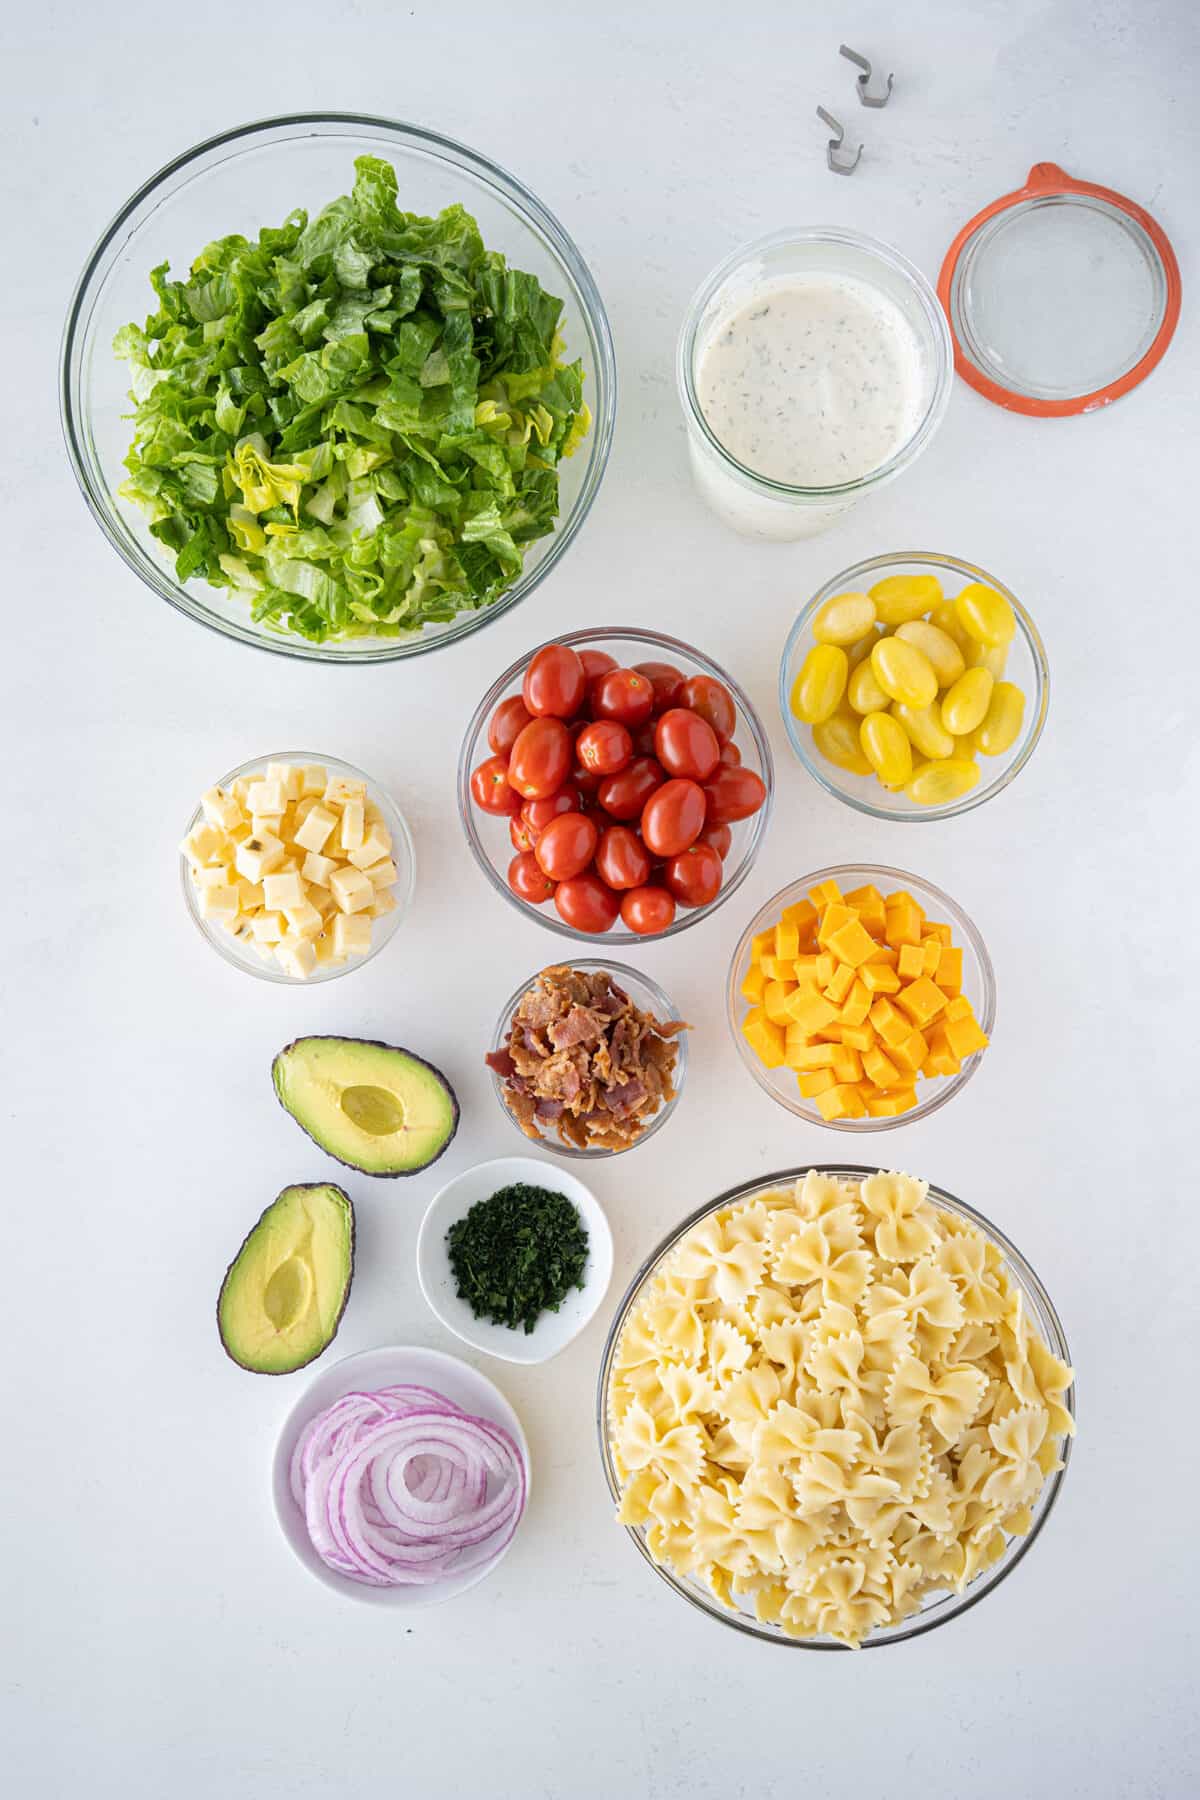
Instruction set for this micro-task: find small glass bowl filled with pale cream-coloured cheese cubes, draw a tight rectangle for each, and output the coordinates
[180,751,414,983]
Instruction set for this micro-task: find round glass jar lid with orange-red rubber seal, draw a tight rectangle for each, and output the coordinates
[937,162,1180,418]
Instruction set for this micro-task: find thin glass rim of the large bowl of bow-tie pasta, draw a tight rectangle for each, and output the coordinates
[596,1163,1076,1651]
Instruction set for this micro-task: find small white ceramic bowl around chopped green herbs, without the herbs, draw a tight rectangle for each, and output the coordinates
[417,1156,612,1363]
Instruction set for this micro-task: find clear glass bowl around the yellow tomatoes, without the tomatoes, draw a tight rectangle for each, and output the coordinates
[779,551,1051,824]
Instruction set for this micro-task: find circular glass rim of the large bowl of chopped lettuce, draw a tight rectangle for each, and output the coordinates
[59,112,617,668]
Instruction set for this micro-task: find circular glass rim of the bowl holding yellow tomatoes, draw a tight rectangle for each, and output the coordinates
[779,551,1051,824]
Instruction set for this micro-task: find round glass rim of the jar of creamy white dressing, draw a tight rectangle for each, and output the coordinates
[675,225,954,500]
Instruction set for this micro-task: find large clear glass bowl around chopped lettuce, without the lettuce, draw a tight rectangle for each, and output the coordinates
[61,113,617,662]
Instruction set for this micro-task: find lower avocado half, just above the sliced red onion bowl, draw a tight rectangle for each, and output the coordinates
[216,1183,354,1375]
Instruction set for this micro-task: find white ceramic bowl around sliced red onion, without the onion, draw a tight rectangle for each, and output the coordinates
[272,1345,533,1611]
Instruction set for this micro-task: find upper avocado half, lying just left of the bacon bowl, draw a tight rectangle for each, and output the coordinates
[272,1037,459,1175]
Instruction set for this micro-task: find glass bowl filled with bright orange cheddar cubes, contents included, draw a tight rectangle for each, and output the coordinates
[727,864,997,1132]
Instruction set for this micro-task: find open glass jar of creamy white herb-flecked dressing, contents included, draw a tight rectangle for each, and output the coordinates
[676,227,954,540]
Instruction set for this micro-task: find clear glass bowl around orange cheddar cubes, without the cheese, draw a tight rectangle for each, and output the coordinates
[725,862,997,1132]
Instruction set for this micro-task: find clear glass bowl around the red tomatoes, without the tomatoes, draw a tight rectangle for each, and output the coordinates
[459,625,775,947]
